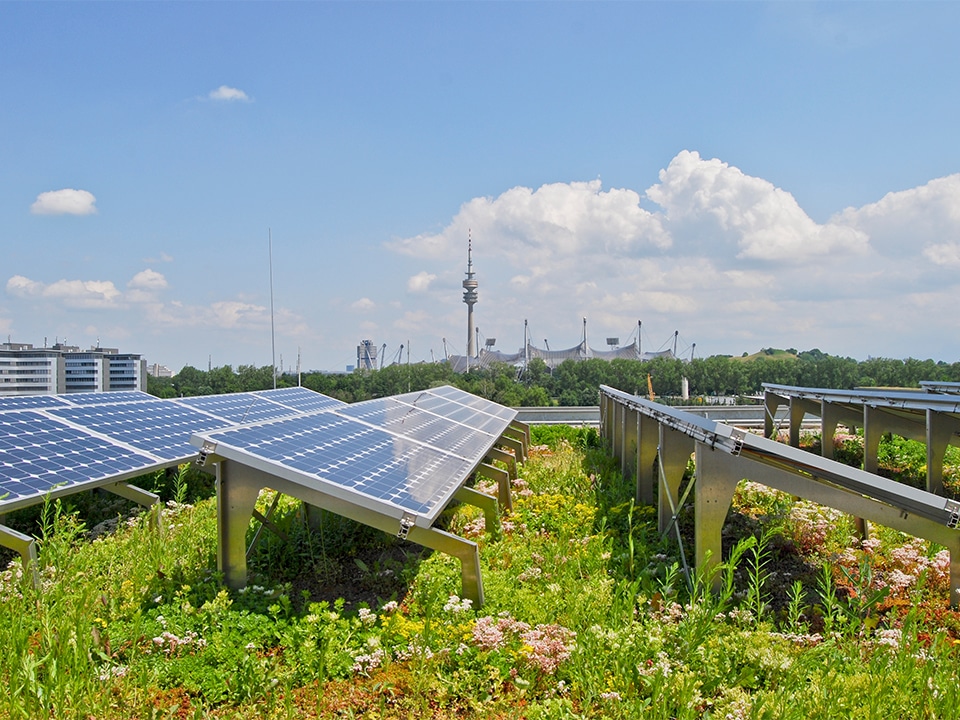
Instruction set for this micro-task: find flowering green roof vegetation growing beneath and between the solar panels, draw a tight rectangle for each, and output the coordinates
[0,429,960,720]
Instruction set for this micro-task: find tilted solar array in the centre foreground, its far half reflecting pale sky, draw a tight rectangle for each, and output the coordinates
[193,387,516,524]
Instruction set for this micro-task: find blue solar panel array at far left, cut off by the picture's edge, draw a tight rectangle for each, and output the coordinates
[0,388,344,512]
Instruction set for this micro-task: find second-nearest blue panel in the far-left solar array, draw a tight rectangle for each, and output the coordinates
[46,400,231,460]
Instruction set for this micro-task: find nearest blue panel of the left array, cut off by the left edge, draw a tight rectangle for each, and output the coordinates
[0,411,158,505]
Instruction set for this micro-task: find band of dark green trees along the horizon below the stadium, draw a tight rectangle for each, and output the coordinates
[147,350,960,407]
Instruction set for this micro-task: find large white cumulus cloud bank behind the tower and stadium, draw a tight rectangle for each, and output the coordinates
[388,150,960,355]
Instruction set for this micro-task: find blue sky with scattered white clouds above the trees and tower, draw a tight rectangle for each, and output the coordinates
[0,2,960,371]
